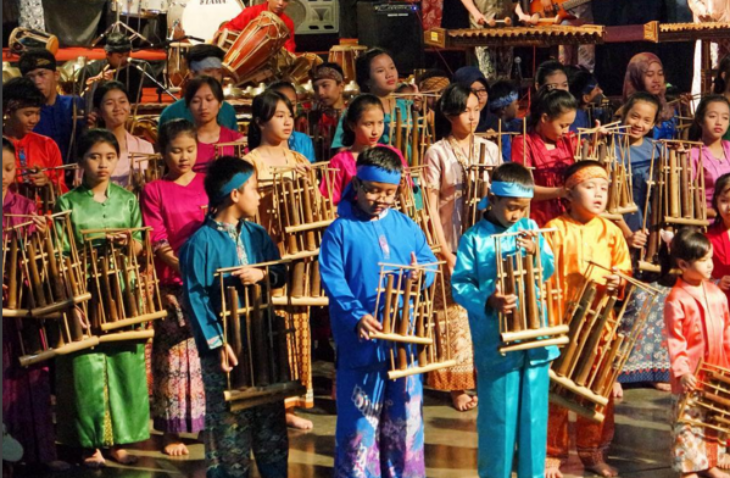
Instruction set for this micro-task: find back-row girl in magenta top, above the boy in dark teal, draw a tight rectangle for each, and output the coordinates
[185,76,243,172]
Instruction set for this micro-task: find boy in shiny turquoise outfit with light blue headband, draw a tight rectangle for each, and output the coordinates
[451,163,558,478]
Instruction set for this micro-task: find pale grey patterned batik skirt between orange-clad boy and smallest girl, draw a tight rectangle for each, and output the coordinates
[618,283,672,383]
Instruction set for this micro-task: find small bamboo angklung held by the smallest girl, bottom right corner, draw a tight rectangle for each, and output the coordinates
[676,359,730,434]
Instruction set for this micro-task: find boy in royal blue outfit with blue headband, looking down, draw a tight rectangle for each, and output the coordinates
[319,146,436,478]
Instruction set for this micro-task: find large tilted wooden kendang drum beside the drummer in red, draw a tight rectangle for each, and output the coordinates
[223,12,289,83]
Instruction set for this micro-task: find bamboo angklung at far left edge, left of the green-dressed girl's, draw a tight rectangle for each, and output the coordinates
[3,211,99,367]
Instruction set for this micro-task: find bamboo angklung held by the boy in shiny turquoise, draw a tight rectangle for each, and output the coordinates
[493,229,568,355]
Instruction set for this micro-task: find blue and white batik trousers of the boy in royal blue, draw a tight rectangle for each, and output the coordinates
[334,366,426,478]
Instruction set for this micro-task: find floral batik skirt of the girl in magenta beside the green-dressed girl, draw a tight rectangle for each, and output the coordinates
[151,287,205,433]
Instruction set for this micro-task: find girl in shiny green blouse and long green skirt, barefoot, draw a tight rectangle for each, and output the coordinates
[56,129,150,468]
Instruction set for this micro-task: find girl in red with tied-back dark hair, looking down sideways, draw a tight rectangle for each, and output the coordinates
[512,88,578,227]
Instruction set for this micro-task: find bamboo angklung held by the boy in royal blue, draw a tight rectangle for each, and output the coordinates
[370,263,456,380]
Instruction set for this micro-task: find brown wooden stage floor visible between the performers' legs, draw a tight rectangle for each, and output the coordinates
[16,363,677,478]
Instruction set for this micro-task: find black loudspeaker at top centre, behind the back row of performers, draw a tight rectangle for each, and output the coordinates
[357,1,424,77]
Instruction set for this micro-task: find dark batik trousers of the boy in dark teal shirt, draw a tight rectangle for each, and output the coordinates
[201,353,289,478]
